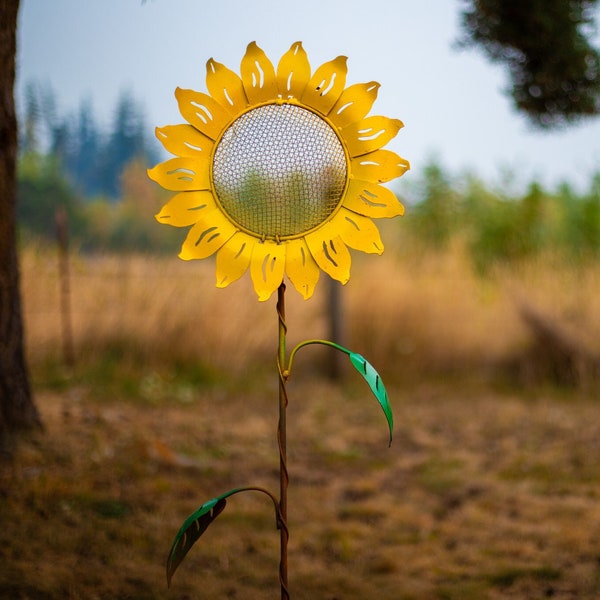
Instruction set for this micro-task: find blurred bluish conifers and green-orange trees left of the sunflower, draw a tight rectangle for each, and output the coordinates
[17,83,180,252]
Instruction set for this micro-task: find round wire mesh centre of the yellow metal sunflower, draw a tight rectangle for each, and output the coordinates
[212,104,347,238]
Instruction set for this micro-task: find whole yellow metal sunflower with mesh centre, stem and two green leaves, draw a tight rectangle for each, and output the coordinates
[148,42,409,599]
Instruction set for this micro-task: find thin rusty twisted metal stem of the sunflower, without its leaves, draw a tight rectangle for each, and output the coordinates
[277,283,290,600]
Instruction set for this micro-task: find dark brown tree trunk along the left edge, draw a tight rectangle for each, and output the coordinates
[0,0,41,450]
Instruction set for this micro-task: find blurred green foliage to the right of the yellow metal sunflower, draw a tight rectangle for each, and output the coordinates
[403,163,600,272]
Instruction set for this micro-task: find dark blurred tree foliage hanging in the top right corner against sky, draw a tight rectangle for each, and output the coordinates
[462,0,600,128]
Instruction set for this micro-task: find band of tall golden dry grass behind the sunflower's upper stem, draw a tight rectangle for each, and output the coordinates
[22,245,600,381]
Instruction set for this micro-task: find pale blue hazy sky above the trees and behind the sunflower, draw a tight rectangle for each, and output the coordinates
[17,0,600,191]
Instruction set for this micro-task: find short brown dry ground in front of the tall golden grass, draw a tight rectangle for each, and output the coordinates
[0,374,600,600]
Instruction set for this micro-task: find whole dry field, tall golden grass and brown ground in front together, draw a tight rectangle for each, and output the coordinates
[0,241,600,600]
